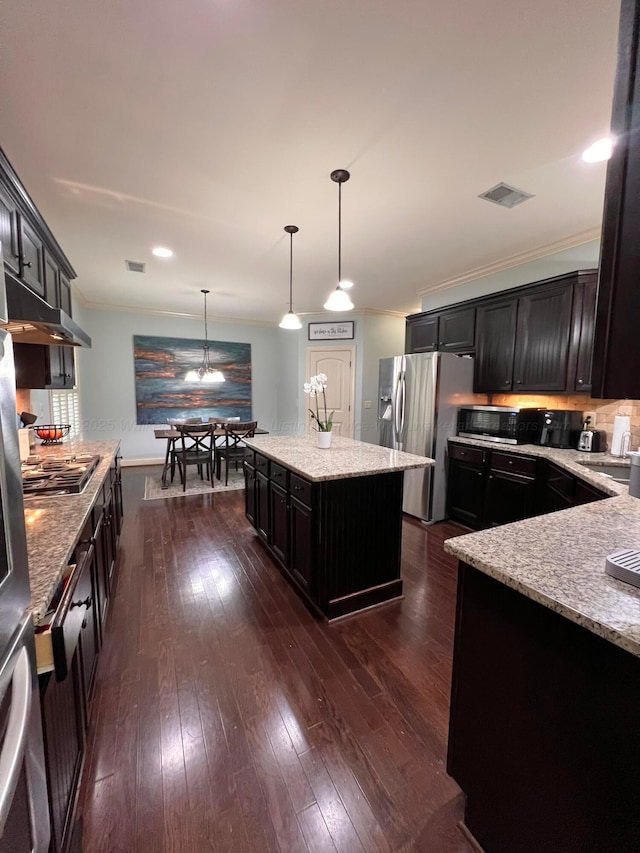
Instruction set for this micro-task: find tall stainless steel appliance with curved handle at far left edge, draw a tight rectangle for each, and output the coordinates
[0,247,50,853]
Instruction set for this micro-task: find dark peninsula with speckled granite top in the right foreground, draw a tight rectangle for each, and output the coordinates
[445,482,640,853]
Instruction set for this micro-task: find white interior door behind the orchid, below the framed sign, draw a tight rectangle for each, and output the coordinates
[305,347,356,438]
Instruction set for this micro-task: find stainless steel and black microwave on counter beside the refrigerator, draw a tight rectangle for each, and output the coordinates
[458,406,539,444]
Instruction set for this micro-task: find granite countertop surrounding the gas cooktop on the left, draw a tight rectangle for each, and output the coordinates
[24,441,120,623]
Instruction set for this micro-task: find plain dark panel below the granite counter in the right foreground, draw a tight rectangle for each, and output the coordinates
[447,563,640,853]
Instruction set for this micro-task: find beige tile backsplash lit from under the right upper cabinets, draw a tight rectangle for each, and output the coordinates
[490,394,640,450]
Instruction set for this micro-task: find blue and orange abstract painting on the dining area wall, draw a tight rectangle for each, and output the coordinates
[133,335,251,424]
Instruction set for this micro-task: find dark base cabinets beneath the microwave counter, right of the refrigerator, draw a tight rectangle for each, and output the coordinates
[447,442,608,529]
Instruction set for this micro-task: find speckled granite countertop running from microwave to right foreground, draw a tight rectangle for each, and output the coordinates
[445,438,640,657]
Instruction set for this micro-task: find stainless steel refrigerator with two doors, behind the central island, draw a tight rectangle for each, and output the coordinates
[378,352,474,522]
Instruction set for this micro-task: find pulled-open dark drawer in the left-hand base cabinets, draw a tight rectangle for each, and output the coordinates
[36,542,94,681]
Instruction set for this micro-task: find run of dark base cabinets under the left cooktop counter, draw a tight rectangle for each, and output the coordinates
[36,460,122,853]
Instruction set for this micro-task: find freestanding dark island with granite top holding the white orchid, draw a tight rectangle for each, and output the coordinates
[245,436,434,619]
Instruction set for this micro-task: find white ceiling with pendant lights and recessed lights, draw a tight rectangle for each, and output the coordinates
[0,0,619,321]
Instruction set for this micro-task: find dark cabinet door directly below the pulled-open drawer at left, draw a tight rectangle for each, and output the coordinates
[40,646,85,853]
